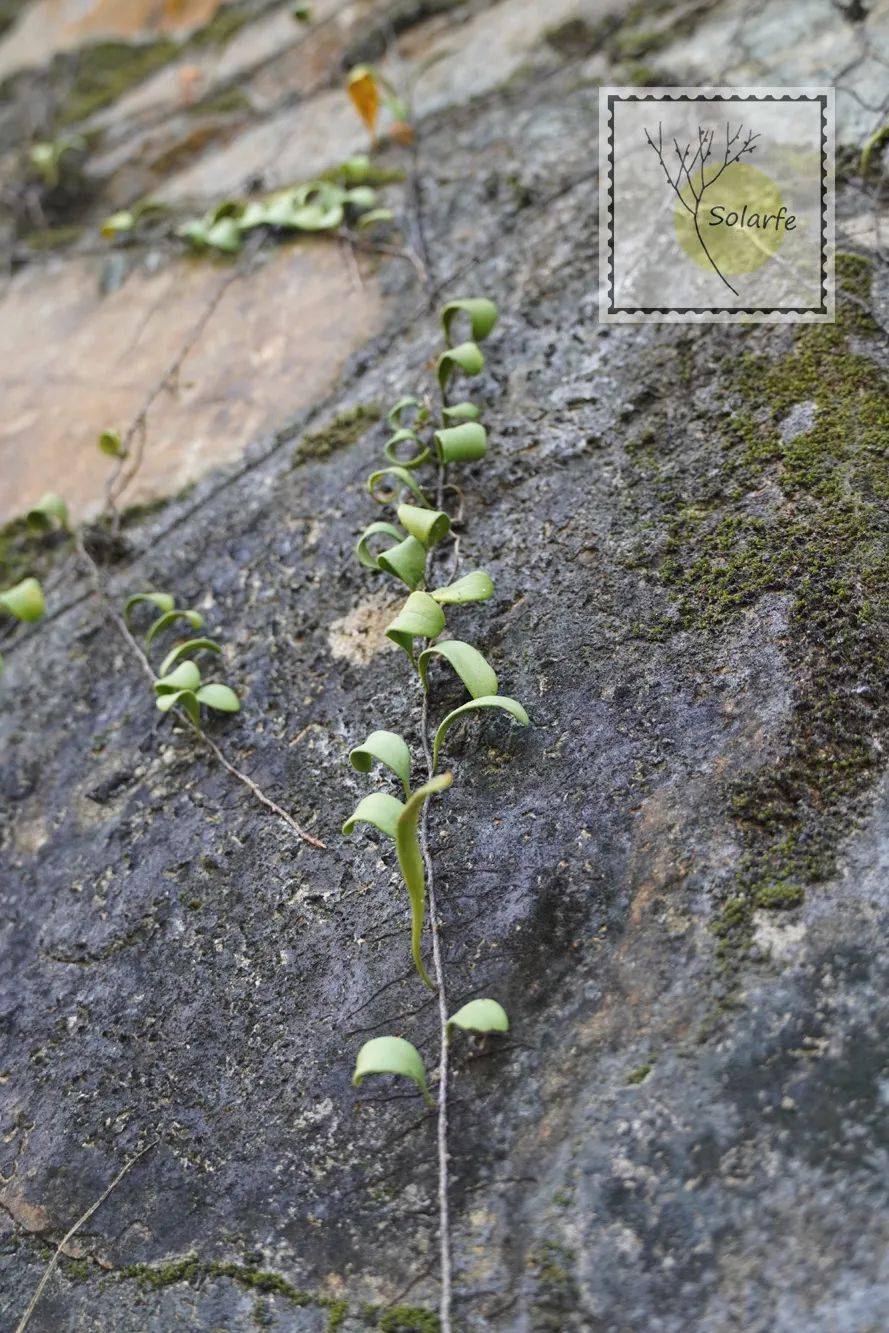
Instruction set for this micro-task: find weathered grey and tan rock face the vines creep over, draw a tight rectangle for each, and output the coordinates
[0,0,889,1333]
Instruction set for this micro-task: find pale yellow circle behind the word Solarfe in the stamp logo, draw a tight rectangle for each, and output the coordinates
[673,163,796,282]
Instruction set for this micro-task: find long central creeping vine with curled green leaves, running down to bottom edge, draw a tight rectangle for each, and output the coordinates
[343,297,528,1333]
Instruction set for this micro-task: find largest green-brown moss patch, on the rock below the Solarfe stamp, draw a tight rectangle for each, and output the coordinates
[633,256,889,958]
